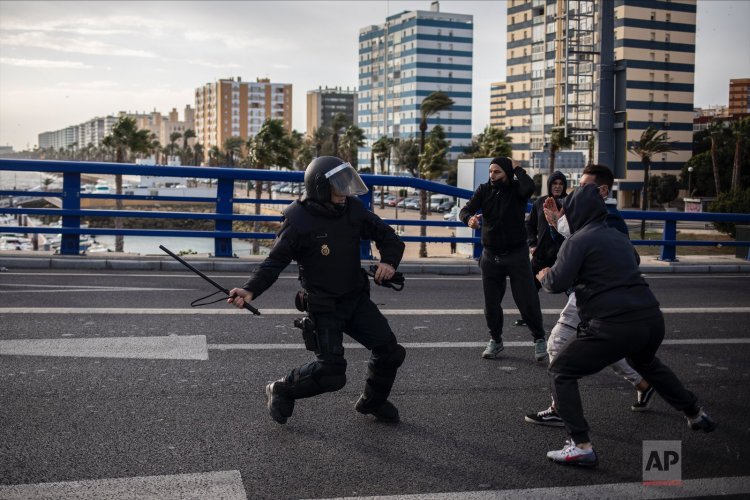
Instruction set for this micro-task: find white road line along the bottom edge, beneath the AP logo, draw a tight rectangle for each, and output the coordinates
[316,476,750,500]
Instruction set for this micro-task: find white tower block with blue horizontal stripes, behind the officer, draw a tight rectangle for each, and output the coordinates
[358,2,474,165]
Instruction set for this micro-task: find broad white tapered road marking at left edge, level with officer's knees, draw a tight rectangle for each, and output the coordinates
[0,335,208,361]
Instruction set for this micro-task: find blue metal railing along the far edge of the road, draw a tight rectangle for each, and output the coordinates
[0,159,750,261]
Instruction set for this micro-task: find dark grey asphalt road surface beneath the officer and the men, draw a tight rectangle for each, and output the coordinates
[0,271,750,499]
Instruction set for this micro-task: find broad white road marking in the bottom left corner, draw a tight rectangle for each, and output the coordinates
[0,470,247,500]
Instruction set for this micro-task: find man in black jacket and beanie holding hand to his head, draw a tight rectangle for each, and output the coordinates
[458,157,547,361]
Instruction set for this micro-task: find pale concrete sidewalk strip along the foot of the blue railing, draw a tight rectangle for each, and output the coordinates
[0,251,750,275]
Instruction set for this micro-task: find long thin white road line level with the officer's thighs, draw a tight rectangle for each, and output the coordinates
[0,303,750,314]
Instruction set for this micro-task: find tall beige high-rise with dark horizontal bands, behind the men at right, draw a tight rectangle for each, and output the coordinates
[506,0,696,206]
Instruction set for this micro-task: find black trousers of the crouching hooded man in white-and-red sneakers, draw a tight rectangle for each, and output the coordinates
[549,309,698,444]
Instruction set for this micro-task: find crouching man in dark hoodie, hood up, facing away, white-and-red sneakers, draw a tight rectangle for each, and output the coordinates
[537,184,716,466]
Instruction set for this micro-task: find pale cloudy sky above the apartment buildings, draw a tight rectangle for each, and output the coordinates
[0,0,750,150]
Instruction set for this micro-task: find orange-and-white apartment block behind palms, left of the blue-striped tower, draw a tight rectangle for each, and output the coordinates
[195,77,292,154]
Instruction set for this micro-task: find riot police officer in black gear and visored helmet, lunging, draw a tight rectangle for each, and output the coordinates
[228,156,406,424]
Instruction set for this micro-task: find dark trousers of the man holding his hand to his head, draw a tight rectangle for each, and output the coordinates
[479,245,544,341]
